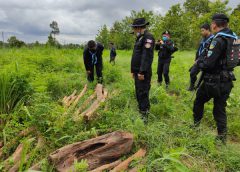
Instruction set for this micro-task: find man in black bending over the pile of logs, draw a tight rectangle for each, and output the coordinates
[83,40,104,83]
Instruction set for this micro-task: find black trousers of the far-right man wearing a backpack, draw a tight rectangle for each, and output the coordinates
[193,81,233,135]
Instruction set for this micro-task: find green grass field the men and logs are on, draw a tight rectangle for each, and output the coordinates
[0,48,240,172]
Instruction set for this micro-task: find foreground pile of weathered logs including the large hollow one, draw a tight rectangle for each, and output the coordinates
[0,129,146,172]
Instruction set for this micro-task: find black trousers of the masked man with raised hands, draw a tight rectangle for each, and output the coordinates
[157,62,170,84]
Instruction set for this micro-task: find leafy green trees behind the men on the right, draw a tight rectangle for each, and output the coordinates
[96,0,240,50]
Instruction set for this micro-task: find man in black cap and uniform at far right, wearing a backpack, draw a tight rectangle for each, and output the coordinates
[193,14,235,143]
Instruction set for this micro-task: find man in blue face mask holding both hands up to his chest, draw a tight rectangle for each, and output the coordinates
[155,31,174,88]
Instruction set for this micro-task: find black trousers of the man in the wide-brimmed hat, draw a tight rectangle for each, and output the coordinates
[134,72,152,111]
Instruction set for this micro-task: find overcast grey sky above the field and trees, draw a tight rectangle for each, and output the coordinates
[0,0,239,43]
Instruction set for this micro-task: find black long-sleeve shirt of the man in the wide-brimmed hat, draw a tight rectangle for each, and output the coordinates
[131,31,155,74]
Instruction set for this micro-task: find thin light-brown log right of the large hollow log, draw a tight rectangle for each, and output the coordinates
[111,149,146,172]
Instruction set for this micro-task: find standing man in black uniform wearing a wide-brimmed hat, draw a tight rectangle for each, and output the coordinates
[131,18,155,123]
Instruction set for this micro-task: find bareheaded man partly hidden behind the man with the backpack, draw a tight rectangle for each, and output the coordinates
[188,23,213,91]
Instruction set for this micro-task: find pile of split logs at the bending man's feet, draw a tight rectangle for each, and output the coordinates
[62,84,107,121]
